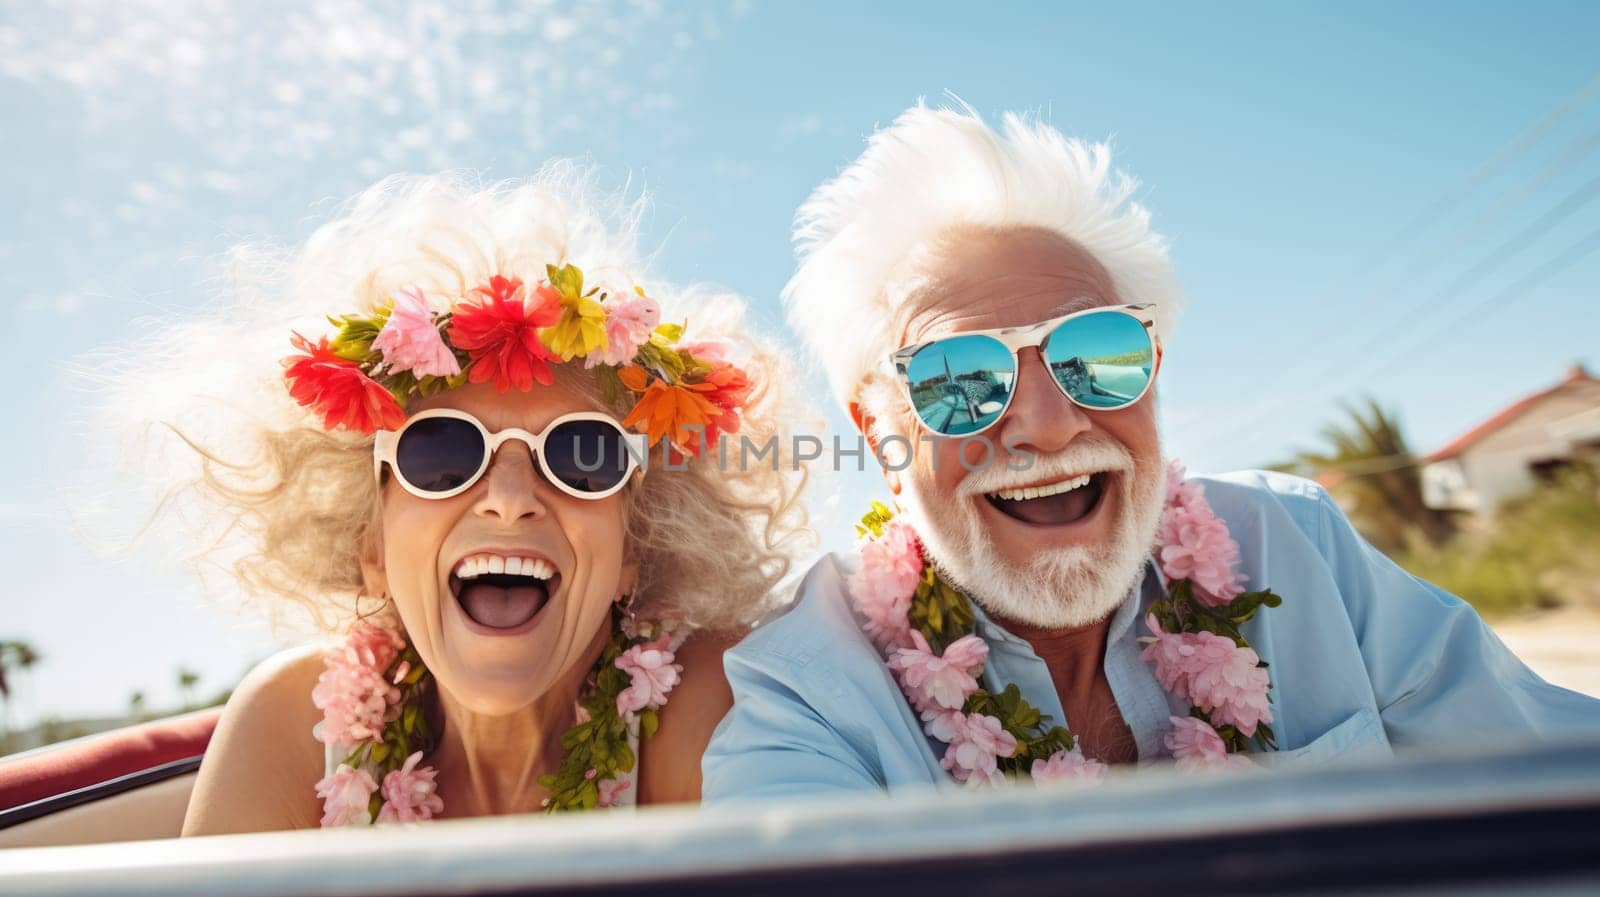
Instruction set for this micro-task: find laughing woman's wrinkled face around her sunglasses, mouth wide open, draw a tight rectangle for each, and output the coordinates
[363,384,632,715]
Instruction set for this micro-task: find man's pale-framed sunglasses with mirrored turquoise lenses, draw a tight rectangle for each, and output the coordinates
[890,305,1157,437]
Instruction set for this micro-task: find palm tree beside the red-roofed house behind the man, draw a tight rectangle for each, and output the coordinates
[1296,398,1456,553]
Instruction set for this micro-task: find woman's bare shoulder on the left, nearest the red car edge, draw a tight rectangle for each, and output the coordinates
[184,644,323,835]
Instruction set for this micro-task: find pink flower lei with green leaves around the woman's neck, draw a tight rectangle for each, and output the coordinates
[312,614,688,827]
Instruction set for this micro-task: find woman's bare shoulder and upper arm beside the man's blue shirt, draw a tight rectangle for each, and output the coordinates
[638,632,739,804]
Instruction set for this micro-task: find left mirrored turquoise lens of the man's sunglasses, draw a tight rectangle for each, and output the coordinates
[906,334,1016,437]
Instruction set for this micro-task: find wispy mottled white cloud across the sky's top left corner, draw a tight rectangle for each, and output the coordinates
[0,0,726,224]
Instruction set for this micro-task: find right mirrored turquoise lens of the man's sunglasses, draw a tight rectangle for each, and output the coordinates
[1043,312,1155,409]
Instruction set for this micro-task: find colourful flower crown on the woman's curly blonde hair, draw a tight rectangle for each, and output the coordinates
[283,264,750,456]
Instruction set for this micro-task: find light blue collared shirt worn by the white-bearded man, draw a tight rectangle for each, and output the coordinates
[702,472,1600,803]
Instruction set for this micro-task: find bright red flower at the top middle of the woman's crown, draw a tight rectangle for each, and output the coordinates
[450,275,562,392]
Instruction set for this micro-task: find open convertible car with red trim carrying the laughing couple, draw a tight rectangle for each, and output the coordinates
[0,712,1600,897]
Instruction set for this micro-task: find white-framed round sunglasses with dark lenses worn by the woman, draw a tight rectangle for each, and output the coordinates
[373,408,650,500]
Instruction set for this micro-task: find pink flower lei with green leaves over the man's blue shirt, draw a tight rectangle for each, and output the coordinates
[848,462,1280,785]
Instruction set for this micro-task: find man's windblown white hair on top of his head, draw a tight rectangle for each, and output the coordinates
[784,102,1182,405]
